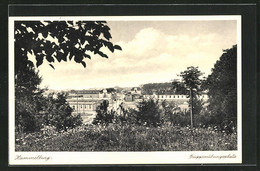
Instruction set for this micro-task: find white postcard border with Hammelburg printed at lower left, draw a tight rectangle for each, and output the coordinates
[8,15,242,165]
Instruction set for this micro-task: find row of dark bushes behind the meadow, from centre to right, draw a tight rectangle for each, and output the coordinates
[92,99,236,133]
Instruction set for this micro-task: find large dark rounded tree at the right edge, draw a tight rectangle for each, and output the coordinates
[207,45,237,126]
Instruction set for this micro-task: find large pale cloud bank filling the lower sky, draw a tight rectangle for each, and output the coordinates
[37,27,238,89]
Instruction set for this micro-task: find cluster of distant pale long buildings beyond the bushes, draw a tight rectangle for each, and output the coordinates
[67,87,208,122]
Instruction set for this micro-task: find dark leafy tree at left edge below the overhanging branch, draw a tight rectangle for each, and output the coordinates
[15,66,44,132]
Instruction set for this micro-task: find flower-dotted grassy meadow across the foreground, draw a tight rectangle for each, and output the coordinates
[15,125,237,151]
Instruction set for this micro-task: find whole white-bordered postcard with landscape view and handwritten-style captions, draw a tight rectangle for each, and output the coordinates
[9,15,242,165]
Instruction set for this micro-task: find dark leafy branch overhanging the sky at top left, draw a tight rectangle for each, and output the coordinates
[15,21,121,70]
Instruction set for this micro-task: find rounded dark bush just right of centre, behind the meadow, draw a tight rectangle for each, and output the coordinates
[136,99,161,126]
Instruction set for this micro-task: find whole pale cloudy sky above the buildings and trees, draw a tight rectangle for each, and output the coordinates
[30,20,237,90]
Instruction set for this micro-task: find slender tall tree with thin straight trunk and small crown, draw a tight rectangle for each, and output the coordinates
[180,66,203,127]
